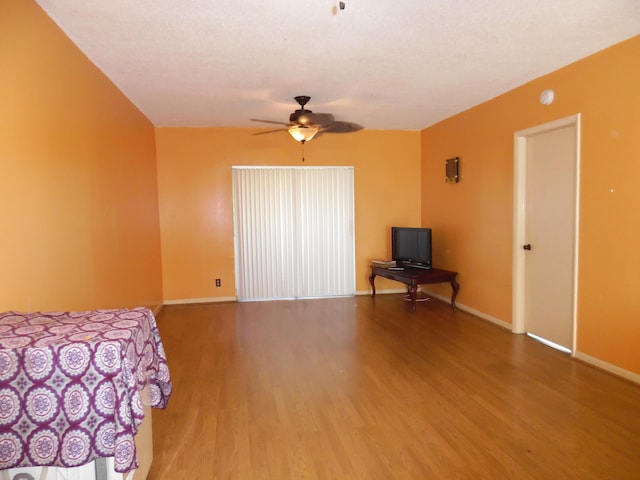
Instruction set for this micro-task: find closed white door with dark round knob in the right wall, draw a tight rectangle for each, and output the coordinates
[514,117,579,351]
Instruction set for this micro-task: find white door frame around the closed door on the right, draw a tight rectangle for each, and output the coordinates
[511,113,581,356]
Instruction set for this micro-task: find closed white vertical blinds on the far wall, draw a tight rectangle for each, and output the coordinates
[232,167,355,301]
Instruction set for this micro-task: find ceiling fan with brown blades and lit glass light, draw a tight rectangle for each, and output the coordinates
[250,95,363,144]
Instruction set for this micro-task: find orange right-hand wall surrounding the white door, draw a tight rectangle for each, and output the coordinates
[422,37,640,373]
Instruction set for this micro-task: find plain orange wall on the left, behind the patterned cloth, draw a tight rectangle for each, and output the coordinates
[0,0,162,311]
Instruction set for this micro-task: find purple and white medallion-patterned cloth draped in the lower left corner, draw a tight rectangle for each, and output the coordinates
[0,308,172,473]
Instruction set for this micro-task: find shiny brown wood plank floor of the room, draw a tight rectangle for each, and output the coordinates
[148,295,640,480]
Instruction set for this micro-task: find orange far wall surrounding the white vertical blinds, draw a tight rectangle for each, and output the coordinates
[156,128,420,301]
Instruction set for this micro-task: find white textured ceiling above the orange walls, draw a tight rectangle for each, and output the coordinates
[37,0,640,130]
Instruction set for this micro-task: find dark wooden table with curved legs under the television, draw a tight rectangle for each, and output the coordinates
[369,266,460,312]
